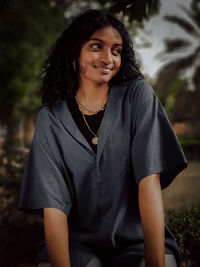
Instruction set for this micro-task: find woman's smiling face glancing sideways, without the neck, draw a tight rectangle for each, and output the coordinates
[79,26,123,84]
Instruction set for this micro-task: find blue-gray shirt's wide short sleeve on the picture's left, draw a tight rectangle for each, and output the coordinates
[18,107,72,217]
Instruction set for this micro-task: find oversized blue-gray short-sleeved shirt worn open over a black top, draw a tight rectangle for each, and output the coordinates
[19,78,187,267]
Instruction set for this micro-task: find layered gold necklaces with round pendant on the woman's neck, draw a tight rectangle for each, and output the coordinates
[75,95,106,145]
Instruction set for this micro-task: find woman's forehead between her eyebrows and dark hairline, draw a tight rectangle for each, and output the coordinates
[90,26,123,45]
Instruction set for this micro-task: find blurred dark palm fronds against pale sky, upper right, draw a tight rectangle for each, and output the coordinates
[155,0,200,91]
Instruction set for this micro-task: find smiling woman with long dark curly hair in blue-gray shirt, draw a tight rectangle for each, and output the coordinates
[19,10,187,267]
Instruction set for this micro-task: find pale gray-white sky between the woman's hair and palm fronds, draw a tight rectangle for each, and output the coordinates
[135,0,195,78]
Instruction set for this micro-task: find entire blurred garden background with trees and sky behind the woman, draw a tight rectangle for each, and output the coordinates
[0,0,200,267]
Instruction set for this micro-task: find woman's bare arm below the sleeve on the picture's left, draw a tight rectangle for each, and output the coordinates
[44,208,71,267]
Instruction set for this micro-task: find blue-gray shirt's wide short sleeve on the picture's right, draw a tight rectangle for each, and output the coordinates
[131,80,187,189]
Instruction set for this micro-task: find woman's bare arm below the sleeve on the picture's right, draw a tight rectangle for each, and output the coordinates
[139,173,165,267]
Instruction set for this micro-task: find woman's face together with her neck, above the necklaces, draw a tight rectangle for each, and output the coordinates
[76,26,123,122]
